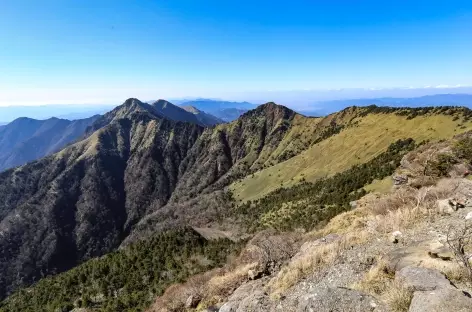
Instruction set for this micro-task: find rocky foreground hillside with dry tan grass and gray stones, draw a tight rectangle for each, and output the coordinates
[147,132,472,312]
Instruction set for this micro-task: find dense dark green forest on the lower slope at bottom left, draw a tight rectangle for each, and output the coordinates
[0,228,243,312]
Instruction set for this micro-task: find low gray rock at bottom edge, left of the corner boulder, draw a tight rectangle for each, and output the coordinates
[296,288,387,312]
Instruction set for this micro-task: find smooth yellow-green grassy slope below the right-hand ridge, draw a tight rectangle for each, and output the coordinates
[230,113,472,201]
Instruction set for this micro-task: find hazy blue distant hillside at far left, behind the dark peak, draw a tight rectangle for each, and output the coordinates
[0,116,99,171]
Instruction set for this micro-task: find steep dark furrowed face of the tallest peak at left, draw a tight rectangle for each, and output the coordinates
[0,99,203,296]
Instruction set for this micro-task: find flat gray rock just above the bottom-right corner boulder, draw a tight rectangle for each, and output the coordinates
[395,266,453,291]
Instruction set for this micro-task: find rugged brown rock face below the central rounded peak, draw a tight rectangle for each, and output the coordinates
[170,103,296,197]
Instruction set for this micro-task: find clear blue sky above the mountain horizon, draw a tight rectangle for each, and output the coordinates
[0,0,472,105]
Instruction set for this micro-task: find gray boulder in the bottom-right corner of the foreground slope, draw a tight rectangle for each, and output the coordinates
[408,288,472,312]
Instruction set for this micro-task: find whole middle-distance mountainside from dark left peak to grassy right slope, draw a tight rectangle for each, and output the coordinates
[0,99,472,311]
